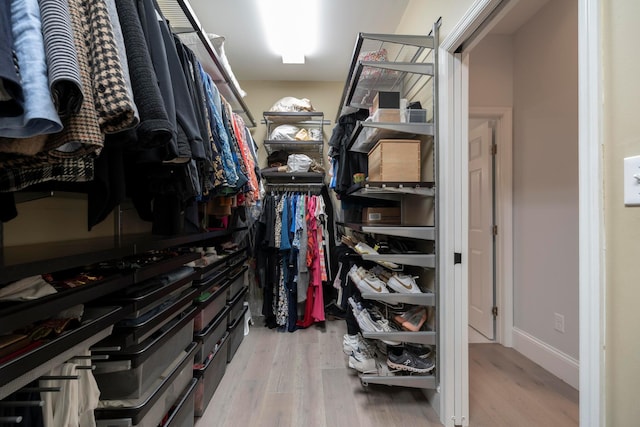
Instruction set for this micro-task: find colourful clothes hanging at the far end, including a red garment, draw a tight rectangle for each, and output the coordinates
[254,192,330,332]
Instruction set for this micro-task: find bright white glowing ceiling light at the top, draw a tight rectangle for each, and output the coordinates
[256,0,320,64]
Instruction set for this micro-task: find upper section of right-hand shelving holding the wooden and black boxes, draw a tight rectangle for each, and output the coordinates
[332,33,436,197]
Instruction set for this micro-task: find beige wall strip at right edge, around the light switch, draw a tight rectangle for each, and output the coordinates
[601,0,640,427]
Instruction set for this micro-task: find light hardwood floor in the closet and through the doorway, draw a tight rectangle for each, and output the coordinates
[196,321,578,427]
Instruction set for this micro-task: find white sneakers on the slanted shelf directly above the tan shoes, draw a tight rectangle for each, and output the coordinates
[348,264,422,294]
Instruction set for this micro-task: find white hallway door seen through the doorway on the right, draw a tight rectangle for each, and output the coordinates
[469,121,495,340]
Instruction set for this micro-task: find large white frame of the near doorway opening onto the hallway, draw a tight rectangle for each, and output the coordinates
[437,0,606,427]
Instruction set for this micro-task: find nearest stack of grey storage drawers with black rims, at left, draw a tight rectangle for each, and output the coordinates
[92,263,198,427]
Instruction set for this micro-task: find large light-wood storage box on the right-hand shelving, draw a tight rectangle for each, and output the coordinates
[369,139,420,182]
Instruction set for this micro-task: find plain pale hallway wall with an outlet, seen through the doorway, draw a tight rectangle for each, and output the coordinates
[513,0,579,359]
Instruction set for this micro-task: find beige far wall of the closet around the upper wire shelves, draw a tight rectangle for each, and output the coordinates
[241,80,346,167]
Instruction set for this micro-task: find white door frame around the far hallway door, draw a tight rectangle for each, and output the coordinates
[469,107,513,347]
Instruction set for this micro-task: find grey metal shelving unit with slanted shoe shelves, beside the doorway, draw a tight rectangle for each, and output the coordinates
[336,22,443,389]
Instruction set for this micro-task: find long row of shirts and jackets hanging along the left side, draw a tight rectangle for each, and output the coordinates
[0,0,262,234]
